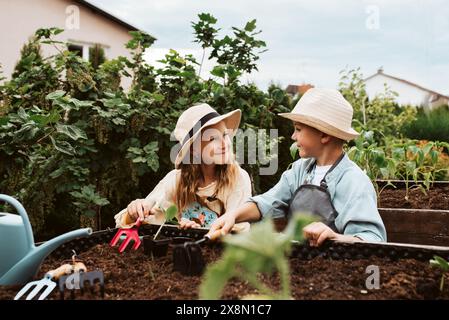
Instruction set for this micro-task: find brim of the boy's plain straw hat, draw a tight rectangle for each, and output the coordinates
[278,113,360,141]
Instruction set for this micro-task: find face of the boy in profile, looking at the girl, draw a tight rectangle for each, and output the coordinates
[292,122,322,158]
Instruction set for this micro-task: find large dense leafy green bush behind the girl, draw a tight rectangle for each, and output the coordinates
[0,14,291,239]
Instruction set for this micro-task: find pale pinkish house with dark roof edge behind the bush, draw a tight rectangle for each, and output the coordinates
[0,0,152,86]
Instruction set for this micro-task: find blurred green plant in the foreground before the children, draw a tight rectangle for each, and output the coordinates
[200,214,312,299]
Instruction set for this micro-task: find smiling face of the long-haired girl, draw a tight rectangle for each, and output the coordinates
[197,121,232,165]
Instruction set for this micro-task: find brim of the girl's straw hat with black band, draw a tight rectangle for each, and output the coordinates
[175,109,242,169]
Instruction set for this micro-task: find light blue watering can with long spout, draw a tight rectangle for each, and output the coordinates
[0,194,92,285]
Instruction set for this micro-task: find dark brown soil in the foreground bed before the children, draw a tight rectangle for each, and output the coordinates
[0,244,449,300]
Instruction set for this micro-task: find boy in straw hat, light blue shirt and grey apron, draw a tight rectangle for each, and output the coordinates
[206,88,386,246]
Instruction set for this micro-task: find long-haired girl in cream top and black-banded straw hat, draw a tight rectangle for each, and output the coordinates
[115,104,251,228]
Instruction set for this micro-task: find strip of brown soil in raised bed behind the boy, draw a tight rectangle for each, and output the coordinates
[378,186,449,210]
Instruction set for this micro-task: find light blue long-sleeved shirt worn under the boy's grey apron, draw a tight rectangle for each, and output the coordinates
[249,154,387,242]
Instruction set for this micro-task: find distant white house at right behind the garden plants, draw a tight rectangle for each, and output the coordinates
[364,68,449,110]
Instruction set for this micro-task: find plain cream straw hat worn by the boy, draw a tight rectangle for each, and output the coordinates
[279,88,359,141]
